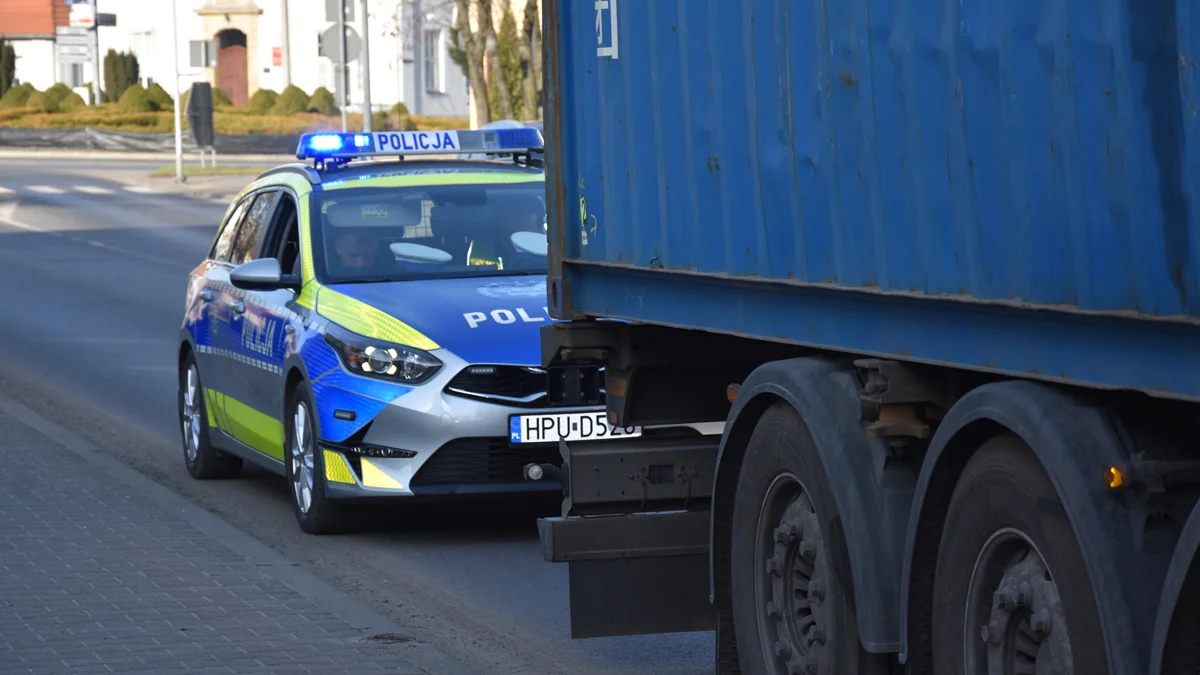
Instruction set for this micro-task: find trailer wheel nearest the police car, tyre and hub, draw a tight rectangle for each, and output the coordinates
[731,404,887,675]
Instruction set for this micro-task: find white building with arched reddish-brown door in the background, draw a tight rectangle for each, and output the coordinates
[82,0,469,118]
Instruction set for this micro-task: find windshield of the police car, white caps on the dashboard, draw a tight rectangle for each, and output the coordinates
[312,181,547,283]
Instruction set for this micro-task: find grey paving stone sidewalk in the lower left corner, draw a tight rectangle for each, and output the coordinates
[0,407,446,674]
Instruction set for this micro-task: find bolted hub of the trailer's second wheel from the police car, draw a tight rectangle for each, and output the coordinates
[966,533,1074,675]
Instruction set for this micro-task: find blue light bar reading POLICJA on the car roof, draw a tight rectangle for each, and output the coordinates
[296,126,545,160]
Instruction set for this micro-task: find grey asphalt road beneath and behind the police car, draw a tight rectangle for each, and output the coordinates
[0,159,714,675]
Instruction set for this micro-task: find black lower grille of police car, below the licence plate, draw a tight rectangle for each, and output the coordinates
[412,437,563,489]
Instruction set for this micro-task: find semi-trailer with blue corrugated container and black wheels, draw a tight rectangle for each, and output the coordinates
[534,0,1200,675]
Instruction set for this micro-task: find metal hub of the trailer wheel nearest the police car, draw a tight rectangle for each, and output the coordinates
[761,494,830,675]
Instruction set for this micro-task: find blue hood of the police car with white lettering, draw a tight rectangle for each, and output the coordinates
[318,275,551,365]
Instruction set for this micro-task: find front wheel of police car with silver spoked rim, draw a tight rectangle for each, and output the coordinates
[283,383,349,534]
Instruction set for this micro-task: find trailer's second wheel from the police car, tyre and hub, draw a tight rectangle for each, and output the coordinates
[932,435,1109,675]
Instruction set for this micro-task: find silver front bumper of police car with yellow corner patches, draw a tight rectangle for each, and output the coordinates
[320,353,724,500]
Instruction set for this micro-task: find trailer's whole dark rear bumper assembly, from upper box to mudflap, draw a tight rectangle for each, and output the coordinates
[538,435,720,639]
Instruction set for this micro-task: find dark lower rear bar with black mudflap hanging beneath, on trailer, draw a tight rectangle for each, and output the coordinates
[538,510,716,639]
